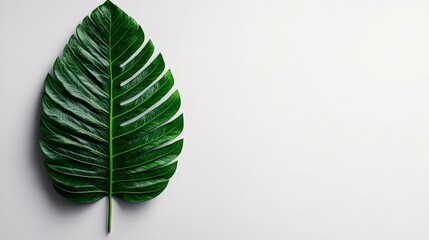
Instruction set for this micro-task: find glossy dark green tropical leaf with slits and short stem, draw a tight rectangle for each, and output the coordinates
[40,1,183,232]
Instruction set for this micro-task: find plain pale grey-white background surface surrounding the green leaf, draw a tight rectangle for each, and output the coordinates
[0,0,429,240]
